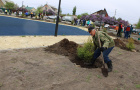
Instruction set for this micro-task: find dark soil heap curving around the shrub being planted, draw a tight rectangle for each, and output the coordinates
[45,39,102,68]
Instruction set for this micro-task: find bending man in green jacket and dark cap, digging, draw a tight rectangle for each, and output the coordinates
[88,27,115,72]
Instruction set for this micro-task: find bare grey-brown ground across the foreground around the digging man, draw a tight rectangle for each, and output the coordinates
[0,38,140,90]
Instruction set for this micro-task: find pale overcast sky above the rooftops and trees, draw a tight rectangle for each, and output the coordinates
[12,0,140,24]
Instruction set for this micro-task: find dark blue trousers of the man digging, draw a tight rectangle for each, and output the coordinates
[93,47,114,63]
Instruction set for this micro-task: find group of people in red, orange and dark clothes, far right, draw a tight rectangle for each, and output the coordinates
[116,23,133,39]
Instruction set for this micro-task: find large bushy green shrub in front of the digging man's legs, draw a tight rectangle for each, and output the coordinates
[77,38,95,63]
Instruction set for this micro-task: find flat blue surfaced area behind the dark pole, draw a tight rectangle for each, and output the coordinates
[0,16,89,36]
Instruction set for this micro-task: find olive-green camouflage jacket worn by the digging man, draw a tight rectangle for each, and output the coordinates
[93,31,115,48]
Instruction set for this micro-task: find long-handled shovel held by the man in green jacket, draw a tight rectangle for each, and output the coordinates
[97,28,108,77]
